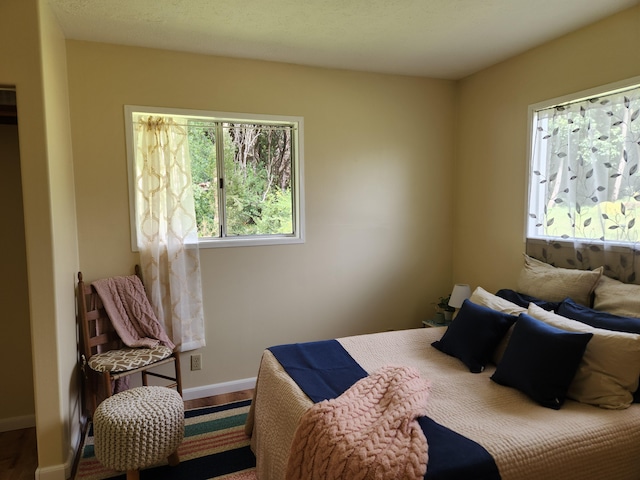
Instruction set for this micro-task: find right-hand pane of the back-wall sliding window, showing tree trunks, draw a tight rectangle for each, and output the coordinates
[224,123,294,236]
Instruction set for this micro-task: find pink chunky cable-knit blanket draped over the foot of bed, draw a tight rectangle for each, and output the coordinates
[286,366,429,480]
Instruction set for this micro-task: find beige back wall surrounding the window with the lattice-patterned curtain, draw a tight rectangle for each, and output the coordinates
[67,41,454,388]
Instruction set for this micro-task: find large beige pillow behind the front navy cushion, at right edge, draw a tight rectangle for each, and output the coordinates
[527,303,640,409]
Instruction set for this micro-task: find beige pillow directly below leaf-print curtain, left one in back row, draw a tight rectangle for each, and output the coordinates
[517,254,603,307]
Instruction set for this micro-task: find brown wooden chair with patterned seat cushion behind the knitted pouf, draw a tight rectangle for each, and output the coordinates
[77,265,182,417]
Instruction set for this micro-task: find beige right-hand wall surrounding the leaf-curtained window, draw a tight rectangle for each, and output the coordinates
[453,6,640,290]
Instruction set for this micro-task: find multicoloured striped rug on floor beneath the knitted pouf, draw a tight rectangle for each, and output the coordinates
[75,400,256,480]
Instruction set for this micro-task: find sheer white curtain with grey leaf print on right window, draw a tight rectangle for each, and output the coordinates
[527,87,640,283]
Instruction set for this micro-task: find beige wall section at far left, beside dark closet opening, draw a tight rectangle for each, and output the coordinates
[0,0,79,480]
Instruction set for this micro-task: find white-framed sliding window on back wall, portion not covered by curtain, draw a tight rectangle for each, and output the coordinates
[130,107,303,246]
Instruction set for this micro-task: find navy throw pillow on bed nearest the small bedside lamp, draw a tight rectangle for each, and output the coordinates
[431,300,517,373]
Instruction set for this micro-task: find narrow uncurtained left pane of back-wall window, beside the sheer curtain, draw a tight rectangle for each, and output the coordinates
[189,121,220,238]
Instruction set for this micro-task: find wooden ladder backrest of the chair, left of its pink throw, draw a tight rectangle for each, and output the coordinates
[78,272,122,360]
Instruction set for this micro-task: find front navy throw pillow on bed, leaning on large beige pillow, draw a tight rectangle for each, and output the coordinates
[491,313,593,410]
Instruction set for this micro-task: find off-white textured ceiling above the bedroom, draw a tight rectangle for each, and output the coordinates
[49,0,639,79]
